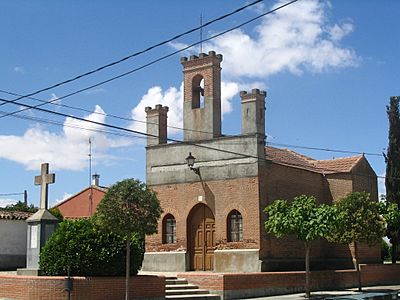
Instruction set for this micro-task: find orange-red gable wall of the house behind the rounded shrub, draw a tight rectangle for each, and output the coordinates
[56,188,105,219]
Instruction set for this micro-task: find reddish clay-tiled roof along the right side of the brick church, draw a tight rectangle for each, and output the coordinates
[265,146,362,174]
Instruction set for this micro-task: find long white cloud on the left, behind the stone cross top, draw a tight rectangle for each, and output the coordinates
[0,105,130,170]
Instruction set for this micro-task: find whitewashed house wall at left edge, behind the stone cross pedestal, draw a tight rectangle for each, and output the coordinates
[0,219,27,270]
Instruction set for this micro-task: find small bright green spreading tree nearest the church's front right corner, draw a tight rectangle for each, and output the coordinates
[264,195,337,298]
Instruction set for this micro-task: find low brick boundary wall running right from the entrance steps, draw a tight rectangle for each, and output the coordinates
[178,264,400,299]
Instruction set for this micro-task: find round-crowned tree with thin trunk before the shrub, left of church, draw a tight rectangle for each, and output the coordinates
[95,179,162,300]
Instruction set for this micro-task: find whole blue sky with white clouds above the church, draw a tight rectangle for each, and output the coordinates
[0,0,400,207]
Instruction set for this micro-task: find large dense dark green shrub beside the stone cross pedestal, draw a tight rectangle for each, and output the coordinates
[39,219,144,276]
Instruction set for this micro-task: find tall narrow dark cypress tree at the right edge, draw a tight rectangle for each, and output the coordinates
[384,97,400,263]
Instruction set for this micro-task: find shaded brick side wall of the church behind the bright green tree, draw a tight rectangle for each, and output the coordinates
[260,163,331,271]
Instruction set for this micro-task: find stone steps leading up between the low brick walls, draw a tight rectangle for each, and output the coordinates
[165,277,221,300]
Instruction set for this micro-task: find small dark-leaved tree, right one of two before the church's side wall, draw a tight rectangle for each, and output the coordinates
[328,192,385,291]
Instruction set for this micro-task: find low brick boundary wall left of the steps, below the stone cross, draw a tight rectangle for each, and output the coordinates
[0,275,165,300]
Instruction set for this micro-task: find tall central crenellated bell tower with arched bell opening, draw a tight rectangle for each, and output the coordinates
[181,51,222,141]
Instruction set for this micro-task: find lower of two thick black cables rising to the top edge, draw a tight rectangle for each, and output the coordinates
[0,0,298,119]
